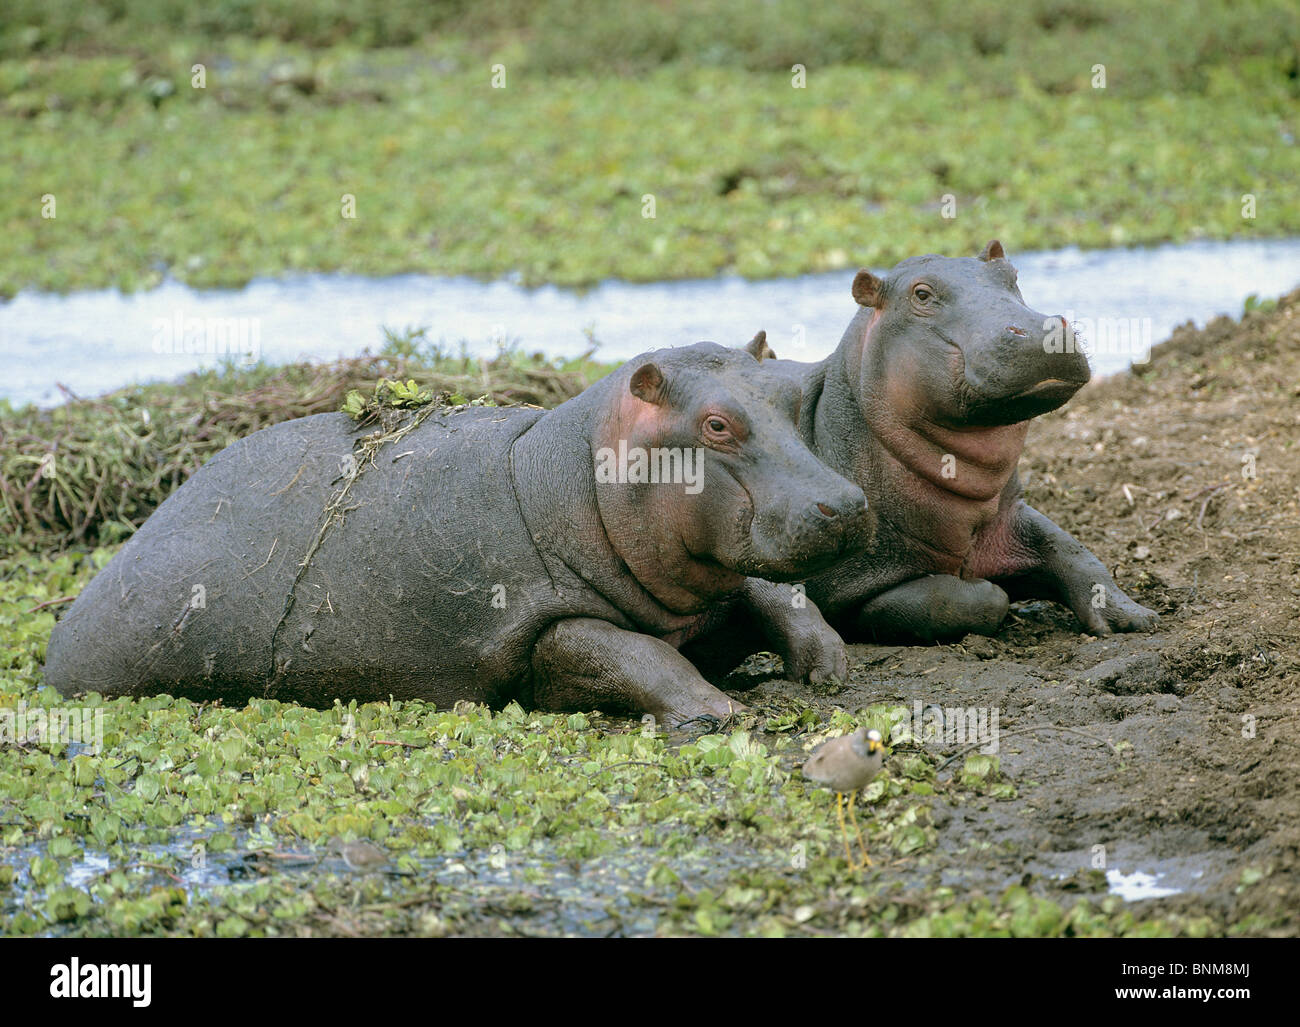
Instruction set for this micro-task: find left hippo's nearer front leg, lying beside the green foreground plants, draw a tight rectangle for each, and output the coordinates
[533,618,745,727]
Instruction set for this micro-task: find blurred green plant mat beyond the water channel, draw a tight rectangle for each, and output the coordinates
[0,36,1300,293]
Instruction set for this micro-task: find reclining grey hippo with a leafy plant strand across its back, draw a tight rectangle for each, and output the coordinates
[46,343,870,725]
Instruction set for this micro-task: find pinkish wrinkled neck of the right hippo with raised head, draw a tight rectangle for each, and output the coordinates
[813,309,1028,573]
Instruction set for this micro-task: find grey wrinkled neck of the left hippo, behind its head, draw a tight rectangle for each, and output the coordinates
[511,373,745,644]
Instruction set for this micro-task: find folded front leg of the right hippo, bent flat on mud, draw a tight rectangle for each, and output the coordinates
[854,575,1010,642]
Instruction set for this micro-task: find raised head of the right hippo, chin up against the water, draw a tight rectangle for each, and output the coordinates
[842,241,1089,428]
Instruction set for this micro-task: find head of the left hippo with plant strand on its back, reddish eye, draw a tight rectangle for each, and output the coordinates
[593,342,870,595]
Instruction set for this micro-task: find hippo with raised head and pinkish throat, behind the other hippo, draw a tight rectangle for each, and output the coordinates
[748,241,1157,642]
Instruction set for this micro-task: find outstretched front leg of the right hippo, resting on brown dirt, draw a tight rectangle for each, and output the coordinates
[995,503,1160,634]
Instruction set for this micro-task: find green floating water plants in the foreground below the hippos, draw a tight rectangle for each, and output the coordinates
[0,549,1213,936]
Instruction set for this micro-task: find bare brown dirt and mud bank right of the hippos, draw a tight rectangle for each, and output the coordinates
[751,290,1300,935]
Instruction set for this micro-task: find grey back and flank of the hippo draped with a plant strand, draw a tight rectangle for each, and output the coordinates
[46,408,569,705]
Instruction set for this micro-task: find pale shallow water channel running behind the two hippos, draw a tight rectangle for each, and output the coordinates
[0,239,1300,406]
